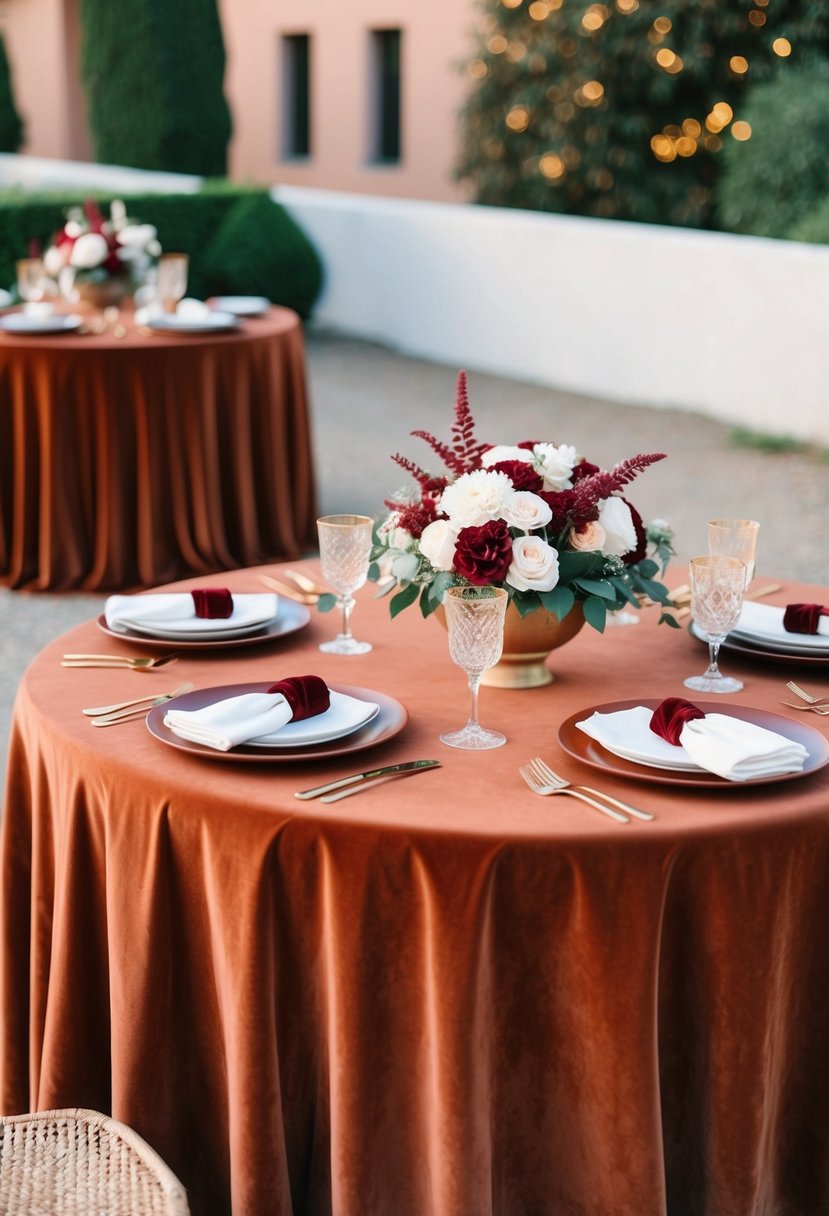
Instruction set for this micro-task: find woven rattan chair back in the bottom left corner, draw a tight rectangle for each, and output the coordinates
[0,1110,190,1216]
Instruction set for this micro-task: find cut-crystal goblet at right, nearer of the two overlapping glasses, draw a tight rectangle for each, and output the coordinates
[684,553,746,692]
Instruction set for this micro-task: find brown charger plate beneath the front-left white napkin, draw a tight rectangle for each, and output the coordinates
[147,675,408,764]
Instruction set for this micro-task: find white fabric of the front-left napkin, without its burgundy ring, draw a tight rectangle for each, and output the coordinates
[164,689,378,751]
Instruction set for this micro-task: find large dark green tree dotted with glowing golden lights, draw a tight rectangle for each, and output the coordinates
[458,0,829,226]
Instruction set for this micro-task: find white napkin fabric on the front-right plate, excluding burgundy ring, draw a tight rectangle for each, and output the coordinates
[576,705,808,781]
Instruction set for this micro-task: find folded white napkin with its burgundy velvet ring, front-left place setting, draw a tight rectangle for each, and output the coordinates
[164,676,377,751]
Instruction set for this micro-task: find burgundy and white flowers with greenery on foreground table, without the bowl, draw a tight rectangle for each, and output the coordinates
[371,372,677,631]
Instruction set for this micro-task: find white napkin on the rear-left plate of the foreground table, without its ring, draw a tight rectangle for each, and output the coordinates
[103,591,278,634]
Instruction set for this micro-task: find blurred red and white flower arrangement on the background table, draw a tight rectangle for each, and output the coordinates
[43,198,162,298]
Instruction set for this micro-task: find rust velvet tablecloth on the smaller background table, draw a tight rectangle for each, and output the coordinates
[0,309,316,590]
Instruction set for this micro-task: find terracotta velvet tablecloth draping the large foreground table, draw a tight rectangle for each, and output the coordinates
[0,570,829,1216]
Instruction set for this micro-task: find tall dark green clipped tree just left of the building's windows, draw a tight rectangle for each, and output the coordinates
[80,0,231,176]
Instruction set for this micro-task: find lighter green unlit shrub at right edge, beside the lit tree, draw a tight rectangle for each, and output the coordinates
[717,63,829,237]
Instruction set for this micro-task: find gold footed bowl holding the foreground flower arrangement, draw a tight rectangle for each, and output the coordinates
[435,603,585,688]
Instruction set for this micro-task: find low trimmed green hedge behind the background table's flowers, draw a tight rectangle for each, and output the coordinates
[0,184,322,317]
